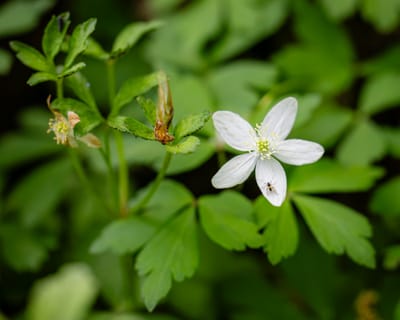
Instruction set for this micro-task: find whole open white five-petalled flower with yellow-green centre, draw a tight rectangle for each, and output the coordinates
[211,97,324,206]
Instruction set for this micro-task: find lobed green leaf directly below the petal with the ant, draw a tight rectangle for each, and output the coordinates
[254,196,299,265]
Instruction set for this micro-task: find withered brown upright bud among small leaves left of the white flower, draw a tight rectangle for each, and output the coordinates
[154,72,174,144]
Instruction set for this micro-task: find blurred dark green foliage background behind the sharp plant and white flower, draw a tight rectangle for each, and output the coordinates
[0,0,400,320]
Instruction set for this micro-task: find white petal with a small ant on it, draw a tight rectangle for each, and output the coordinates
[256,159,286,207]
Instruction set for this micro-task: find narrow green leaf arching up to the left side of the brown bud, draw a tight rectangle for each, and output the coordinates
[111,72,158,116]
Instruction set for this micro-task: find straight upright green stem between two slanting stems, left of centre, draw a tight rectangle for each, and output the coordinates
[114,131,129,217]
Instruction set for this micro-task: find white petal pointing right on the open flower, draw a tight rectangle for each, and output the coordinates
[274,139,324,166]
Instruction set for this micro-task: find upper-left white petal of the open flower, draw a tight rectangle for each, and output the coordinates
[213,111,256,151]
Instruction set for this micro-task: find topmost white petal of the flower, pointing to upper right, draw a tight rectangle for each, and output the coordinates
[260,97,297,141]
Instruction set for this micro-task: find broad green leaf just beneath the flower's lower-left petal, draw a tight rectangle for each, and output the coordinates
[199,191,263,250]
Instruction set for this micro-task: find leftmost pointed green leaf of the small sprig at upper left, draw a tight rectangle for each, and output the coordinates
[10,41,52,72]
